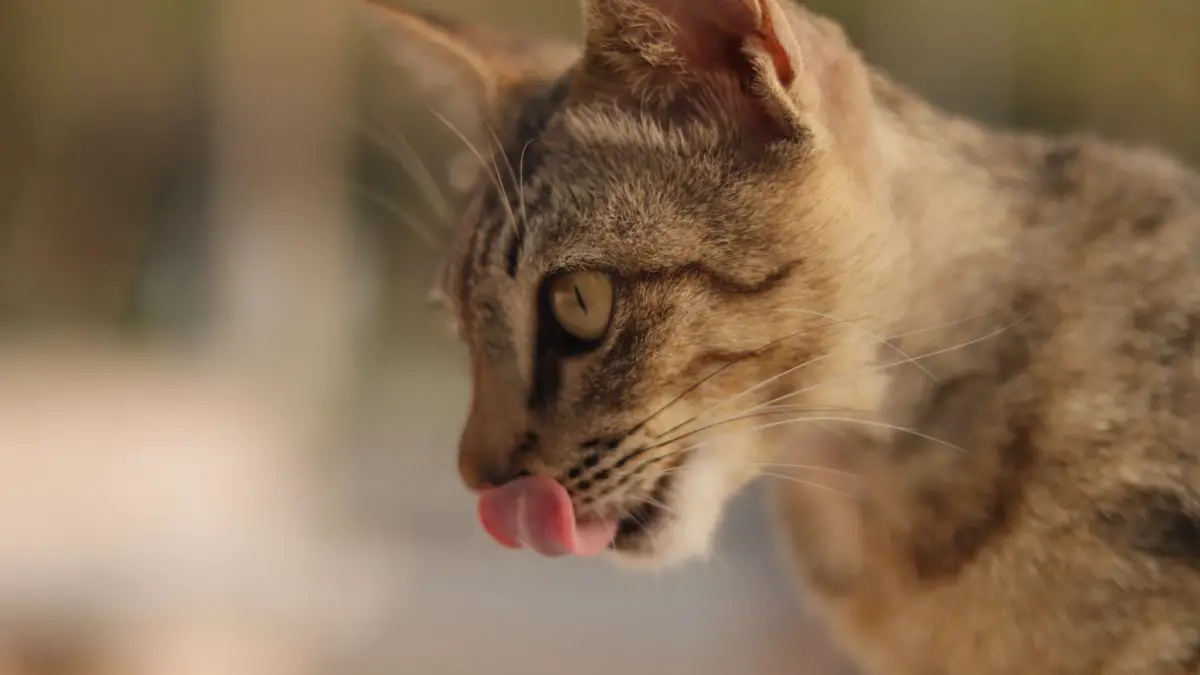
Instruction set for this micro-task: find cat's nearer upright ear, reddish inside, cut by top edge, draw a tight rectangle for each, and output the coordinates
[584,0,848,142]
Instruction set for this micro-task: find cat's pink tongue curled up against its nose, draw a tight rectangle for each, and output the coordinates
[479,476,617,556]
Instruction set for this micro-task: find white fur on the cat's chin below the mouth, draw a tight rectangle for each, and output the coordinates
[613,453,737,569]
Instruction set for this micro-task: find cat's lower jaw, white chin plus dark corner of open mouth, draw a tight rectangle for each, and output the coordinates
[597,456,737,569]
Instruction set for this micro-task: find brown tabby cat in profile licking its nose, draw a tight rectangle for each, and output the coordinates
[364,0,1200,675]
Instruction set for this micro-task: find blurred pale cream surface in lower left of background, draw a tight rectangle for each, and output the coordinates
[0,344,409,675]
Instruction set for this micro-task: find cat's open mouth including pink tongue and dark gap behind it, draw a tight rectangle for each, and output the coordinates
[479,476,671,556]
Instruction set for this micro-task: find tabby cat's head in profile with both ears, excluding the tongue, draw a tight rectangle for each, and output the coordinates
[371,0,907,562]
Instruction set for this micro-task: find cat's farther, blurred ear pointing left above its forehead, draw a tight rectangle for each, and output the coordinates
[359,0,578,136]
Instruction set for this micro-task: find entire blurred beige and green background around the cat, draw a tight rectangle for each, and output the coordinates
[0,0,1200,675]
